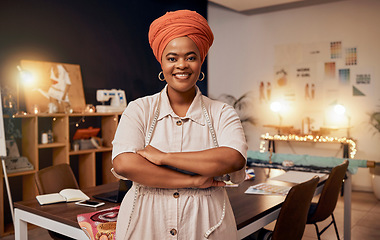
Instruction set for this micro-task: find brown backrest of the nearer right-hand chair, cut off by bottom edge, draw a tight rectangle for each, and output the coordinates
[272,176,319,240]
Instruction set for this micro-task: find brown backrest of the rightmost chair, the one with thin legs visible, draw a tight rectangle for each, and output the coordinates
[307,160,348,223]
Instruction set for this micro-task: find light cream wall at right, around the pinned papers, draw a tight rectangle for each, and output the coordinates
[208,0,380,191]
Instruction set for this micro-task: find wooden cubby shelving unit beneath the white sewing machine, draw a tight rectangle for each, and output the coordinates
[0,113,121,236]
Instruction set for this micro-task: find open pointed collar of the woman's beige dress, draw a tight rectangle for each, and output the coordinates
[157,85,205,125]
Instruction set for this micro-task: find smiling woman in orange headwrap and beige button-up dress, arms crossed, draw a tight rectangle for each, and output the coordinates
[112,10,247,240]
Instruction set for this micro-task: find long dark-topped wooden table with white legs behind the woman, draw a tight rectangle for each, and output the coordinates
[15,168,324,240]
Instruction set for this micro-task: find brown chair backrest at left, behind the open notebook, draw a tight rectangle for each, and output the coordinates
[34,163,79,194]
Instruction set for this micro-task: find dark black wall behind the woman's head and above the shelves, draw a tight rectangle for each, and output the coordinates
[0,0,207,108]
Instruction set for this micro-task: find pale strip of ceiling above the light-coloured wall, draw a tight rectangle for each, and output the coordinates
[208,0,342,15]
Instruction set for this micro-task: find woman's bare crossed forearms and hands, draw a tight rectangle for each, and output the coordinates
[113,146,245,188]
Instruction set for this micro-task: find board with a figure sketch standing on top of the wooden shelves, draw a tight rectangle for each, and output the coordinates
[19,60,86,113]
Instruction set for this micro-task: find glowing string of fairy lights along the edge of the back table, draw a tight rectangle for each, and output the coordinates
[260,133,357,158]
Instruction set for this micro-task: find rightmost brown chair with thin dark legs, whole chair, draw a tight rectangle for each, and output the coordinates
[306,160,349,240]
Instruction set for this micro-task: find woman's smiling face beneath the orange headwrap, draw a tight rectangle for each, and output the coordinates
[161,37,202,96]
